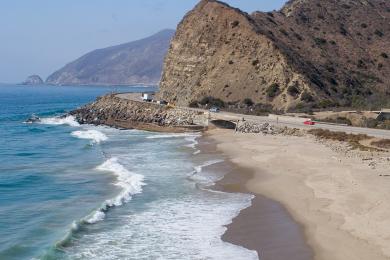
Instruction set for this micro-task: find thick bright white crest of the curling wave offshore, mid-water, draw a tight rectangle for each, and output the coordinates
[83,157,146,224]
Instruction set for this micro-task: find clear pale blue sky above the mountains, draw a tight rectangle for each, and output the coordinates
[0,0,286,83]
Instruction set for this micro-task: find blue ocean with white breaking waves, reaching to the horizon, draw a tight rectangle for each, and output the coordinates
[0,85,258,260]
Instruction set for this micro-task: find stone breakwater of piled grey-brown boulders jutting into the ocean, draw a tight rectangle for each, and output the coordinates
[70,94,207,132]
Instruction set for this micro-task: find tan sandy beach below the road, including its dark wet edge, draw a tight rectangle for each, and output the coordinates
[206,130,390,260]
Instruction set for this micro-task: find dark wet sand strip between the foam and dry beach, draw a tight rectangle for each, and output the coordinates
[200,135,313,260]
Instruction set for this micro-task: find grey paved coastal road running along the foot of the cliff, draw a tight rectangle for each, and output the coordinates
[117,93,390,139]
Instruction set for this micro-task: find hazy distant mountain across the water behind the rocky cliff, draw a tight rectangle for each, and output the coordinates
[46,30,175,85]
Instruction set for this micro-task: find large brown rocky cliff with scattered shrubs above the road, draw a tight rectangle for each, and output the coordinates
[159,0,390,110]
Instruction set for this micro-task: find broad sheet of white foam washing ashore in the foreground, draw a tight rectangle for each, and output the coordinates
[61,189,259,260]
